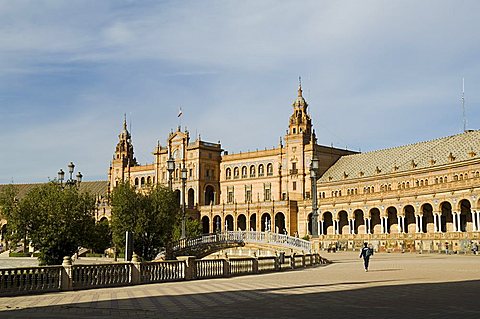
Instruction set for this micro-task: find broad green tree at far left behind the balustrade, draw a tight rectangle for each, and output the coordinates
[0,182,95,265]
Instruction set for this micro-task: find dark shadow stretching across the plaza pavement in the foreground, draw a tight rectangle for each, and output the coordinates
[0,280,480,319]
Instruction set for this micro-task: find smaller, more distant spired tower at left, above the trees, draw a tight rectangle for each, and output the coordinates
[108,116,138,191]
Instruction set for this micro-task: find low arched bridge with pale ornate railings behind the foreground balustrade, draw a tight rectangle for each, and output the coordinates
[173,231,312,258]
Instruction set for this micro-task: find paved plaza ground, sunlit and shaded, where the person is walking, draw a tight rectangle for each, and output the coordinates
[0,252,480,319]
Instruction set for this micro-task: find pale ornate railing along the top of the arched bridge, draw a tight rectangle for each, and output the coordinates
[173,231,312,252]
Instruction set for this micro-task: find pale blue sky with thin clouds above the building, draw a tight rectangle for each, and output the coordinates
[0,0,480,183]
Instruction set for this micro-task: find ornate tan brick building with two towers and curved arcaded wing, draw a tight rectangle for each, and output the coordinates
[108,86,480,254]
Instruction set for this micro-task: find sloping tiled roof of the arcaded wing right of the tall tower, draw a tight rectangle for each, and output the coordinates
[319,130,480,183]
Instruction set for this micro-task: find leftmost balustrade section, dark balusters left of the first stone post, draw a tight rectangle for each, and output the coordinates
[0,266,63,295]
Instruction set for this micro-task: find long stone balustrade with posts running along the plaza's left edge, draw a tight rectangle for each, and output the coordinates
[0,254,326,296]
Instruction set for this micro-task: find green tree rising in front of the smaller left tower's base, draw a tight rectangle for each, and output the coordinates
[112,183,180,260]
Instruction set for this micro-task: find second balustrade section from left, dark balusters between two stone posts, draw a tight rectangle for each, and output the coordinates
[72,263,133,289]
